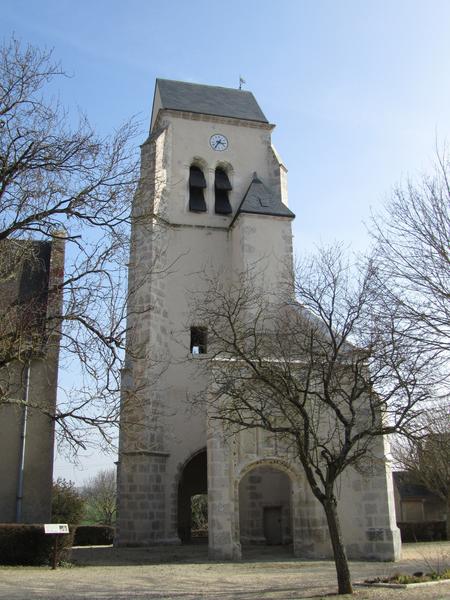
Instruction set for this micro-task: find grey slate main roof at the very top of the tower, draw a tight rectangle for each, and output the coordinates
[156,79,268,123]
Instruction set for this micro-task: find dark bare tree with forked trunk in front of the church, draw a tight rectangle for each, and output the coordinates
[194,247,440,593]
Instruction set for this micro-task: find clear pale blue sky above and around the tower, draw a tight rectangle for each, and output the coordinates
[0,0,450,481]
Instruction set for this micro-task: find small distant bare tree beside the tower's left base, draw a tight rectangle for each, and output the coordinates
[82,469,117,526]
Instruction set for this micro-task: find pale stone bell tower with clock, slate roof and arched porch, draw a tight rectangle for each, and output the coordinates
[116,79,395,559]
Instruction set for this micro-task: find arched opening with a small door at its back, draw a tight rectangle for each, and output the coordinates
[239,465,293,546]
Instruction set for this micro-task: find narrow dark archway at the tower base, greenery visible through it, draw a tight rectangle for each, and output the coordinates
[178,448,208,543]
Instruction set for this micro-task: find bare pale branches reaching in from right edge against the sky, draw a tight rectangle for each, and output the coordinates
[371,153,450,364]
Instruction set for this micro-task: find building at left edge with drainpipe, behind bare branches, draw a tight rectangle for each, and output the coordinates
[0,238,64,523]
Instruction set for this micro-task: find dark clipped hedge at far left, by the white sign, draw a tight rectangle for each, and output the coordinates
[0,523,74,565]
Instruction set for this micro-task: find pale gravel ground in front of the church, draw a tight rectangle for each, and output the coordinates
[0,542,450,600]
